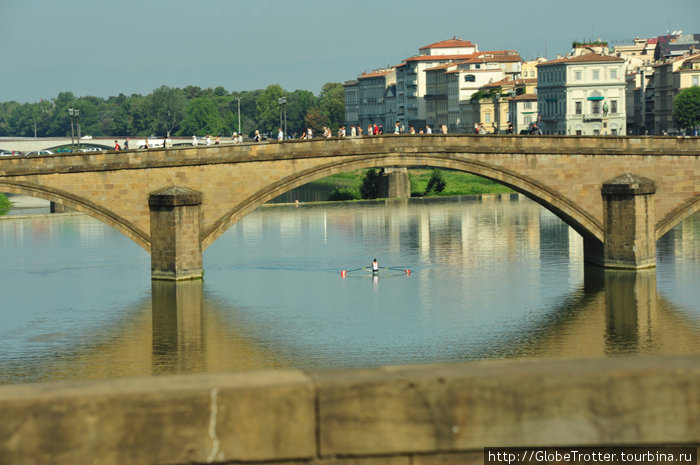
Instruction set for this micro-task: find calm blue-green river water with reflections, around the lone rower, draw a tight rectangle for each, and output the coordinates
[0,195,700,383]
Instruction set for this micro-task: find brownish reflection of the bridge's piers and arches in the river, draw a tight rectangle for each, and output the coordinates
[15,267,700,379]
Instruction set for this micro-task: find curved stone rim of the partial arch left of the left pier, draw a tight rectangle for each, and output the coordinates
[0,180,151,253]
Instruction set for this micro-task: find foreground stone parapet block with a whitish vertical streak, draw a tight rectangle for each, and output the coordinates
[0,371,315,465]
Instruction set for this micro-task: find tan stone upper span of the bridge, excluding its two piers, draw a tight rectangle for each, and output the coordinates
[0,135,700,262]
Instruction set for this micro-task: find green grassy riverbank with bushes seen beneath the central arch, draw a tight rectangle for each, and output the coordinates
[310,168,513,198]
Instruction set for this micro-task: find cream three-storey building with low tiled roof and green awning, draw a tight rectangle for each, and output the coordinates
[537,53,626,135]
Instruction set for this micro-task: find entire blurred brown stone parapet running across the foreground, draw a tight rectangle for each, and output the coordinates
[0,355,700,465]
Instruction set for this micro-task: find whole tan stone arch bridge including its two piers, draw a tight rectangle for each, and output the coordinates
[0,135,700,280]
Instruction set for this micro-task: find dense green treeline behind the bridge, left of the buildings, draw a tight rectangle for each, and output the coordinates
[0,83,345,137]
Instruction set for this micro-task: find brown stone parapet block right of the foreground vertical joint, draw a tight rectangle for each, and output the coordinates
[315,358,700,456]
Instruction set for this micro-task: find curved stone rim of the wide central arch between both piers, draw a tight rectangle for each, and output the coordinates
[202,153,604,251]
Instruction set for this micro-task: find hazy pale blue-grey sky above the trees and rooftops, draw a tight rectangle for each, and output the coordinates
[0,0,700,102]
